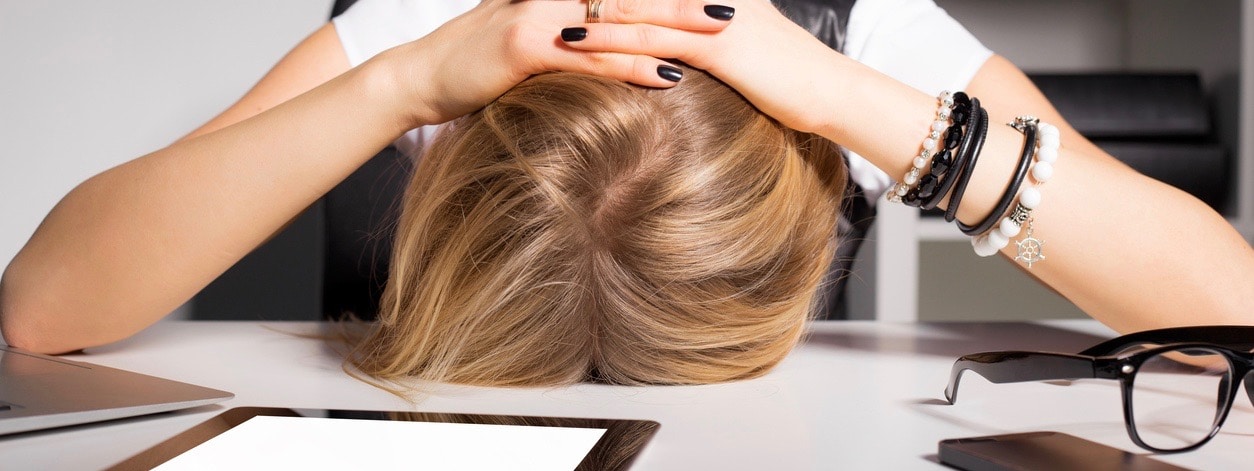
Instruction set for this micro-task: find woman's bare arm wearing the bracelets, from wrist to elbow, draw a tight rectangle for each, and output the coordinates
[821,53,1254,332]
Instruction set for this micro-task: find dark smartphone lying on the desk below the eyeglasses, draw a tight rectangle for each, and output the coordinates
[939,432,1188,471]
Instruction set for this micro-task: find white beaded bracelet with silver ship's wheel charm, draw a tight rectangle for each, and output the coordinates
[971,116,1061,268]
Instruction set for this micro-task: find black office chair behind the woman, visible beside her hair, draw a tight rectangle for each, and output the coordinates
[322,0,874,319]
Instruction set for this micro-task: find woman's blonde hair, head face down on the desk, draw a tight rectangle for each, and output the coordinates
[350,69,845,386]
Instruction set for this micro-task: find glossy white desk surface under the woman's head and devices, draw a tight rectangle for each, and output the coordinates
[0,321,1254,470]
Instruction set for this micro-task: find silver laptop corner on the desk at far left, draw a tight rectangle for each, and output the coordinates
[0,346,234,435]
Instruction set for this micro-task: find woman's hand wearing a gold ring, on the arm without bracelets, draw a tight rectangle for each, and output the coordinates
[374,0,729,127]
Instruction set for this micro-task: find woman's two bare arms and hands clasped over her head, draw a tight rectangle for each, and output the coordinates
[0,0,1254,363]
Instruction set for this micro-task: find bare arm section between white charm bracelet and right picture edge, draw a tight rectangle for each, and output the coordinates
[1003,144,1254,332]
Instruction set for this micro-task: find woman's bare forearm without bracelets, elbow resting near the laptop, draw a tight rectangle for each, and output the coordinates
[0,59,413,352]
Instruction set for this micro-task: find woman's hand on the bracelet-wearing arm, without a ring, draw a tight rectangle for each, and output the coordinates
[566,0,848,134]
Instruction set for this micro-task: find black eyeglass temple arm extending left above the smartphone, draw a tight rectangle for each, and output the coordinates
[944,352,1097,403]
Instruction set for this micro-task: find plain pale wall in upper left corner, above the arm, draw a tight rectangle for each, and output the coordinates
[0,0,331,316]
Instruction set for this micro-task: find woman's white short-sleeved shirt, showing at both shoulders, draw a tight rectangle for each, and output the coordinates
[332,0,992,202]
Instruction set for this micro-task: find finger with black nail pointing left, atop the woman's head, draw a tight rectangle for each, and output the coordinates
[562,24,714,69]
